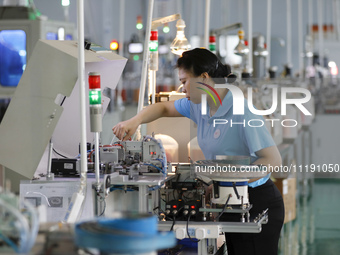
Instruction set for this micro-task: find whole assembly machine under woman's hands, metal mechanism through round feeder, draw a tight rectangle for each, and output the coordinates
[89,143,268,254]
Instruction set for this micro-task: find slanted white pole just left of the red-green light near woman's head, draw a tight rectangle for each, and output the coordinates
[137,0,154,113]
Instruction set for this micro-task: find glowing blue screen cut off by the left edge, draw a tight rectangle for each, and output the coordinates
[0,30,27,87]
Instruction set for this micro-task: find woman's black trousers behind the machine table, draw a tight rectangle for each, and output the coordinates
[220,179,284,255]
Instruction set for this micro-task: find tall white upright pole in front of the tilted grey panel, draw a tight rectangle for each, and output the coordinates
[77,0,87,193]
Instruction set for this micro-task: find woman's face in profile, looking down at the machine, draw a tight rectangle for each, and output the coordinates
[178,68,202,104]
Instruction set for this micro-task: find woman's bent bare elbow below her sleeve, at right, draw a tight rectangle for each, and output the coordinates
[253,146,282,167]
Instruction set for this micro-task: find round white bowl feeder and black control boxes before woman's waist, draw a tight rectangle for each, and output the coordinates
[159,158,267,243]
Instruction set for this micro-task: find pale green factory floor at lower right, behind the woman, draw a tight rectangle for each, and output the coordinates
[279,179,340,255]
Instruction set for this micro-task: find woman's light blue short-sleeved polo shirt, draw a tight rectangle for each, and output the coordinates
[175,91,275,187]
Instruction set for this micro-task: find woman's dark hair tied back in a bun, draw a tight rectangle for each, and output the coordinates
[176,48,231,79]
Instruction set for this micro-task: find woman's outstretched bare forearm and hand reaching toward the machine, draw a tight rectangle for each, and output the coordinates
[112,101,183,141]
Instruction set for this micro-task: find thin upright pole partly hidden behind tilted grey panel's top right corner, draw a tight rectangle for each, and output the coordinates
[117,0,125,107]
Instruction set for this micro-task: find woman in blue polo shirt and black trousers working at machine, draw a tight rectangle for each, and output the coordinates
[112,48,284,255]
